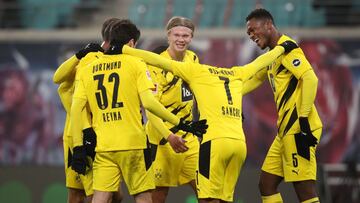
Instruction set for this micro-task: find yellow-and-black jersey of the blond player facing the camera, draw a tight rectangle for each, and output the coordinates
[146,50,199,144]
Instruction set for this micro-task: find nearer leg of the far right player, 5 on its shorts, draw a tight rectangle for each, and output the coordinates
[284,129,322,202]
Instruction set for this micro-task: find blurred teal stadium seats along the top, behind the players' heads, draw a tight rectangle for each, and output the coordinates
[129,0,326,28]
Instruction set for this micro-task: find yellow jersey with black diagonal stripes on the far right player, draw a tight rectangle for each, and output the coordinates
[267,35,322,136]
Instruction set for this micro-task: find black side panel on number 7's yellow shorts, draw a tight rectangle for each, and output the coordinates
[199,140,211,179]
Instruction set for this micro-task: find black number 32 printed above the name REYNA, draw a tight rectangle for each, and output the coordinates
[94,73,124,110]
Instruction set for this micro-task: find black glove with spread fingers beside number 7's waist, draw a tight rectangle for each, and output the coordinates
[176,118,208,138]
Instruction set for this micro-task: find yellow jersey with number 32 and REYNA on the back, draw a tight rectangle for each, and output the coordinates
[73,54,153,152]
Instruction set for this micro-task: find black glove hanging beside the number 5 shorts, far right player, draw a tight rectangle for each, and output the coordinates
[295,117,318,160]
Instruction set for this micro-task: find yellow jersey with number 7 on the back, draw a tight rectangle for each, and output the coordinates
[171,61,255,142]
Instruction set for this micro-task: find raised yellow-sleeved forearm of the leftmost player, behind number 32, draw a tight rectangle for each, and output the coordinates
[53,55,80,84]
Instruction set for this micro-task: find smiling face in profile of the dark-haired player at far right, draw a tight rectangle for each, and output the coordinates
[246,18,272,49]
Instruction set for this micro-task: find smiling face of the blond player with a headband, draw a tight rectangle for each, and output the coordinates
[168,26,193,52]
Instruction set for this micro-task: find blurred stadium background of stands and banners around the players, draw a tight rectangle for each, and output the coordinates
[0,0,360,203]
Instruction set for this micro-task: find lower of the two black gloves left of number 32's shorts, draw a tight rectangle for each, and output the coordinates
[71,146,89,175]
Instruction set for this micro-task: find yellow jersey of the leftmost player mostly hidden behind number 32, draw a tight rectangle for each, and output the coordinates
[59,52,103,141]
